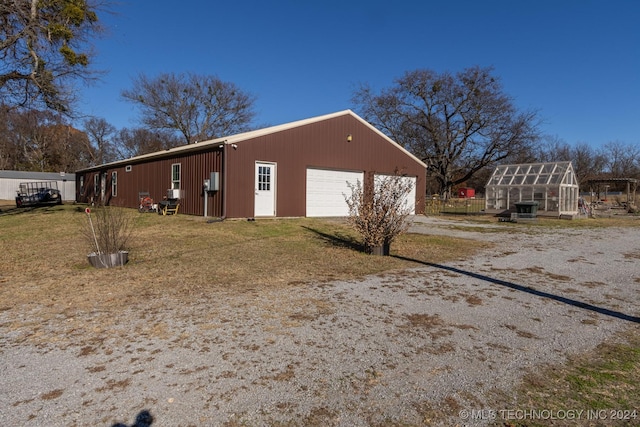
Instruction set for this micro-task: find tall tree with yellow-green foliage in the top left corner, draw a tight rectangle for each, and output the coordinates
[0,0,101,113]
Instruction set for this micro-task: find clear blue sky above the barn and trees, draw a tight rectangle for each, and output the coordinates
[80,0,640,147]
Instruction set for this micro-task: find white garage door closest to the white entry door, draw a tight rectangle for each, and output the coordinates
[307,168,364,217]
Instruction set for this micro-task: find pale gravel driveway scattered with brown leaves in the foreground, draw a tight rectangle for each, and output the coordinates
[0,217,640,427]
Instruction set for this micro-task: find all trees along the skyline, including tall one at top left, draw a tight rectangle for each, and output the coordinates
[0,0,640,192]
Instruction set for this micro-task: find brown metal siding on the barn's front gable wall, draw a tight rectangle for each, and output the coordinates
[227,115,425,218]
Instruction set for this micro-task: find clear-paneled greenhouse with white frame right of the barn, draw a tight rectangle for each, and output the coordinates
[485,162,579,217]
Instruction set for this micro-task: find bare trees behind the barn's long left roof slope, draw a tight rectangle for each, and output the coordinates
[0,74,254,171]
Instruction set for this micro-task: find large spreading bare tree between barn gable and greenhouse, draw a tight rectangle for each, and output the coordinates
[353,67,538,195]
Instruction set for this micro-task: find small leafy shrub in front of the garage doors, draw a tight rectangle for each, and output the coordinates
[345,175,413,255]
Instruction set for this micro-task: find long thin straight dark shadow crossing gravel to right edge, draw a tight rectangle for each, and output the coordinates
[392,255,640,323]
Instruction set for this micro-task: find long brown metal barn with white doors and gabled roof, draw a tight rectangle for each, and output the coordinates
[76,110,426,218]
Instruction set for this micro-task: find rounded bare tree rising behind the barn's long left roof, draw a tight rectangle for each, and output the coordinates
[122,73,255,144]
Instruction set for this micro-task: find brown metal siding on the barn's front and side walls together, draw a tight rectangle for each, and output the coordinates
[76,114,426,218]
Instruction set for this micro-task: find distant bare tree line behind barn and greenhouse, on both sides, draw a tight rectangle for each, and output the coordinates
[0,68,640,197]
